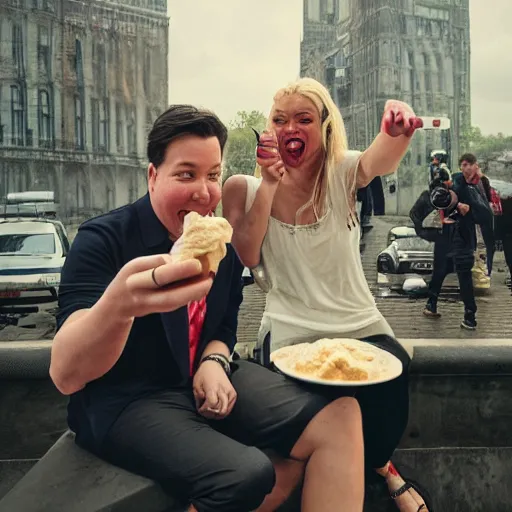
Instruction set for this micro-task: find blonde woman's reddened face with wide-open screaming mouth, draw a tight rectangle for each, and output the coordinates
[272,94,324,169]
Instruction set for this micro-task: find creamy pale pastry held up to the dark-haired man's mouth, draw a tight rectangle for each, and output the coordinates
[171,212,233,276]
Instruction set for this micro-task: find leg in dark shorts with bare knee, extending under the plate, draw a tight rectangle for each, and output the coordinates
[219,361,364,512]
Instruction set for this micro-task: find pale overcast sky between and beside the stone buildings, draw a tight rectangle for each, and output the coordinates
[168,0,512,134]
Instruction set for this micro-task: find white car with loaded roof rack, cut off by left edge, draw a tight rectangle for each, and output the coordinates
[0,198,69,313]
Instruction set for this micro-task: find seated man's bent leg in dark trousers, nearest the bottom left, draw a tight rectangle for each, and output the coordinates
[102,389,275,512]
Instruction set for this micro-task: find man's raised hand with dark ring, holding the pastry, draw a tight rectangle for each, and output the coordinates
[103,254,213,319]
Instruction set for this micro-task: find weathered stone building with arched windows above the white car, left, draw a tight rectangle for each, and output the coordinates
[0,0,169,217]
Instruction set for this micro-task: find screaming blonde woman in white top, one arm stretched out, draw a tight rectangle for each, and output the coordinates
[223,78,432,512]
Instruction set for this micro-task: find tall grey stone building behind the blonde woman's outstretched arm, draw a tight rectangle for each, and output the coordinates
[301,0,471,172]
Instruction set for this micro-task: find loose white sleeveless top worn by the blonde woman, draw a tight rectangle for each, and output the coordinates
[245,151,393,350]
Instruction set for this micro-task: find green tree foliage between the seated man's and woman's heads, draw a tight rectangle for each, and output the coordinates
[224,110,267,180]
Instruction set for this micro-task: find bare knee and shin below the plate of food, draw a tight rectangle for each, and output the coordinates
[291,397,364,512]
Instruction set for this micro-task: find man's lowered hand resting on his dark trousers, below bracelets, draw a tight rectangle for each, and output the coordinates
[193,361,236,420]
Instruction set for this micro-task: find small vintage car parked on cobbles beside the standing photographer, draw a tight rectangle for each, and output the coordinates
[377,226,434,288]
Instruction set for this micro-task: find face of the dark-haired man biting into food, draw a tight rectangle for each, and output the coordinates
[148,135,222,240]
